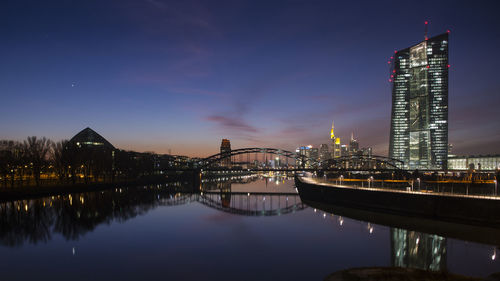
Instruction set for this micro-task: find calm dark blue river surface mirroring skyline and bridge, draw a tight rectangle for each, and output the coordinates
[0,177,500,280]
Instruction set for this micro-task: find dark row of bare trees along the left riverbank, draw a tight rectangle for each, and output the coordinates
[0,136,177,187]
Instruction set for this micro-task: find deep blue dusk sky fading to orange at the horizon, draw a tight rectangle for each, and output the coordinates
[0,0,500,156]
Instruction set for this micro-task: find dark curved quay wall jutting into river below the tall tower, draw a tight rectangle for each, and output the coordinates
[295,177,500,228]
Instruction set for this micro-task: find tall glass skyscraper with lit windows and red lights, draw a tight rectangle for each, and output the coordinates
[389,33,450,169]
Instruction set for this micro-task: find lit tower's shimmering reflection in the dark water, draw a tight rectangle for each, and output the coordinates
[391,228,446,271]
